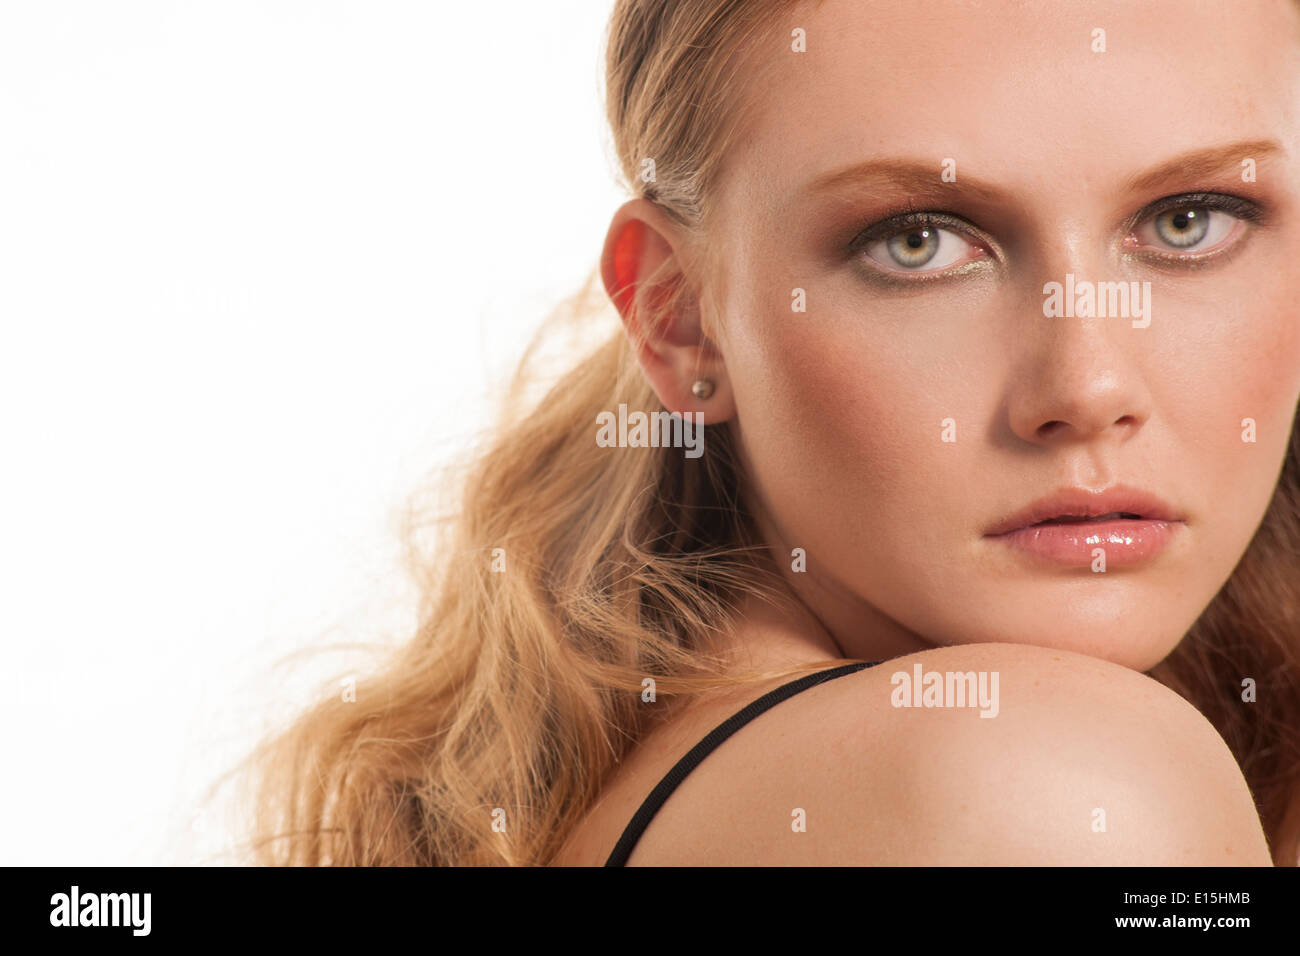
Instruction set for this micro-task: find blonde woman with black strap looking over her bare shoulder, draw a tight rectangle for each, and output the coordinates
[239,0,1300,865]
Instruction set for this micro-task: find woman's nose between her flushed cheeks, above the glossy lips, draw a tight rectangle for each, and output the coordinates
[1008,256,1152,446]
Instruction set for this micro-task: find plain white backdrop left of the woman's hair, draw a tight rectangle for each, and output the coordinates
[0,0,624,865]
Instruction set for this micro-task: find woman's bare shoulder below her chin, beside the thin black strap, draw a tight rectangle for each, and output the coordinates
[629,644,1271,866]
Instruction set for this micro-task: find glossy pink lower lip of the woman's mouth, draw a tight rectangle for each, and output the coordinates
[988,518,1183,567]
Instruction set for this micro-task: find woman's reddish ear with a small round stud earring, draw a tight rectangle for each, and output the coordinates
[601,199,736,424]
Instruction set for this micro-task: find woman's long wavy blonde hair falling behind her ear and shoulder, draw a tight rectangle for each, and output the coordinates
[236,0,1300,865]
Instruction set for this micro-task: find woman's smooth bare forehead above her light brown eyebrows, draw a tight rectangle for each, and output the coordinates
[724,0,1300,210]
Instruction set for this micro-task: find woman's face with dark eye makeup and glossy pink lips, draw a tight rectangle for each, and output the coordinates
[697,0,1300,670]
